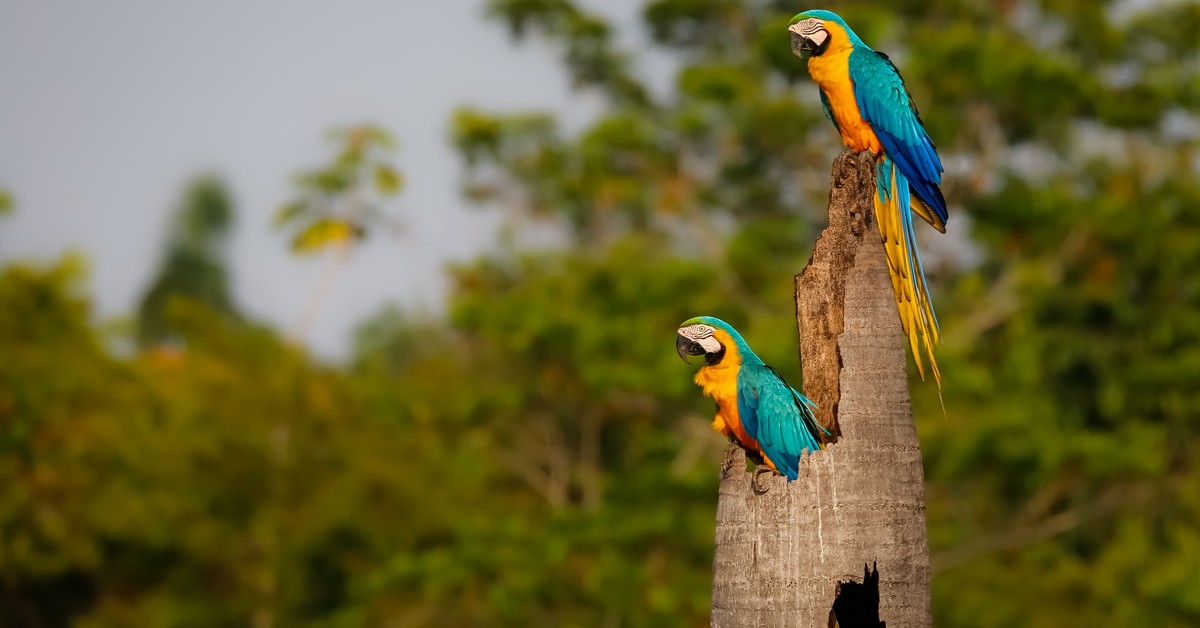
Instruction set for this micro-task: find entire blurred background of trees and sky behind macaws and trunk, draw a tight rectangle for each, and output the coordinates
[0,0,1200,627]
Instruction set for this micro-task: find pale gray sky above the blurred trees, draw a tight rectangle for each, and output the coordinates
[0,0,638,355]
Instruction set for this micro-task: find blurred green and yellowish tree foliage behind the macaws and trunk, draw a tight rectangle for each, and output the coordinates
[0,0,1200,627]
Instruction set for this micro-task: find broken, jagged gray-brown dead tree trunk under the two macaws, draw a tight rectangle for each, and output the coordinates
[712,152,931,628]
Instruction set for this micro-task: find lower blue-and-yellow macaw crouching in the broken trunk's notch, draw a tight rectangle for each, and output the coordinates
[676,316,829,482]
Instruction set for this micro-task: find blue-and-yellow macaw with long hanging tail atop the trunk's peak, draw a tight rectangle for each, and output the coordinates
[787,11,949,388]
